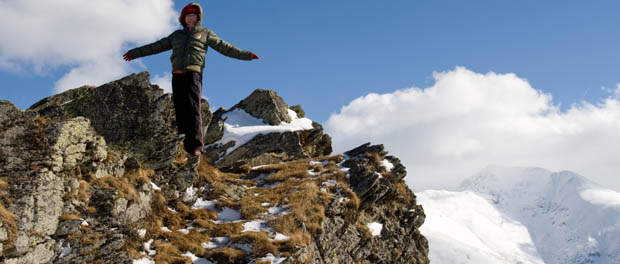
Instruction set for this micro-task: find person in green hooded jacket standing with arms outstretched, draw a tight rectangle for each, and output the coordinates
[123,3,258,156]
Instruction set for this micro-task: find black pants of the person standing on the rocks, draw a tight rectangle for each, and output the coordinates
[172,71,204,153]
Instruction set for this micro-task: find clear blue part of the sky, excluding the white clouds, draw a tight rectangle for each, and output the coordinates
[0,0,620,122]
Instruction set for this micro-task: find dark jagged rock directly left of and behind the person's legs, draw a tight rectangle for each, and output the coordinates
[29,72,211,168]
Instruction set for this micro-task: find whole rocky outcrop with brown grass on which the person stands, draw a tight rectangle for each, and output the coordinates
[0,73,428,263]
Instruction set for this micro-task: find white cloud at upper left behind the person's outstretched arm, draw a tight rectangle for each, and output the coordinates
[0,0,178,92]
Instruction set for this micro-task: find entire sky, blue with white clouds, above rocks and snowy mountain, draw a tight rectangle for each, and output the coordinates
[0,0,620,191]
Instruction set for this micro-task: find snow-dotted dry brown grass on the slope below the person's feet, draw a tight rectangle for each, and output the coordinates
[119,155,359,263]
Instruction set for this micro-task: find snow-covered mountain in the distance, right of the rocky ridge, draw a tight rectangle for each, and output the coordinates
[417,167,620,263]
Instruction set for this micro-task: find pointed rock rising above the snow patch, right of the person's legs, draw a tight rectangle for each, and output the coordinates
[231,89,291,126]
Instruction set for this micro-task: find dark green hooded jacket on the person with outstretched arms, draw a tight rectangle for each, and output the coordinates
[128,3,252,73]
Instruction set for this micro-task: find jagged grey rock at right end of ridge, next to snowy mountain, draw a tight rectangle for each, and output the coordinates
[314,143,429,263]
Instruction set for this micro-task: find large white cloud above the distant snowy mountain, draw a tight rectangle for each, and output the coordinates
[325,67,620,191]
